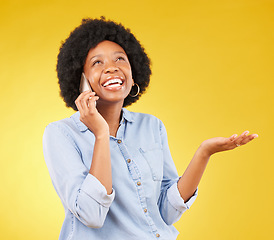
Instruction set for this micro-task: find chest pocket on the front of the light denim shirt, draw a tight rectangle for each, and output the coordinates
[139,143,164,181]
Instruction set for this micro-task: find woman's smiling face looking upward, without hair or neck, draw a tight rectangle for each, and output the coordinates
[84,41,133,104]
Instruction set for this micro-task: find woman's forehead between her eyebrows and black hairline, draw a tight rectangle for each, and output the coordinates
[88,40,126,57]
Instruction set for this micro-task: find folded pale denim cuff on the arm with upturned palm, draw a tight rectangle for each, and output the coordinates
[167,182,198,212]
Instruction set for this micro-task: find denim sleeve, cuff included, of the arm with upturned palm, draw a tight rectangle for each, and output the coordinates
[158,122,198,225]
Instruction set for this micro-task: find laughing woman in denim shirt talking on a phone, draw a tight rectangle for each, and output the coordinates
[43,18,257,240]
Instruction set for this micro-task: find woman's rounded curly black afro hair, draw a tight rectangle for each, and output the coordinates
[56,17,151,111]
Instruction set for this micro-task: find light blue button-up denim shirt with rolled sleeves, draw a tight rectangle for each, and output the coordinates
[43,109,197,240]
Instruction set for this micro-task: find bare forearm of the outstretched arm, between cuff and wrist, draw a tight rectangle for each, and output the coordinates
[178,146,210,202]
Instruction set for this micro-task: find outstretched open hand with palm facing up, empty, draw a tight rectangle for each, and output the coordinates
[200,131,258,156]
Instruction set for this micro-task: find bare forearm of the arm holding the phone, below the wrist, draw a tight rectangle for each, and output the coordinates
[89,134,112,194]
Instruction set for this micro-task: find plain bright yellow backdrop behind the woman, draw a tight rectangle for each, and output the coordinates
[0,0,274,240]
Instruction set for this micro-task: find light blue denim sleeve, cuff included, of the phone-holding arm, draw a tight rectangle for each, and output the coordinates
[43,123,115,228]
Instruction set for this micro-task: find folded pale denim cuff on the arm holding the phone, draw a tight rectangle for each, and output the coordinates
[81,174,115,208]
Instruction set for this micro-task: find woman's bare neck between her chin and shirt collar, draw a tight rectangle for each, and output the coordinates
[96,102,123,137]
